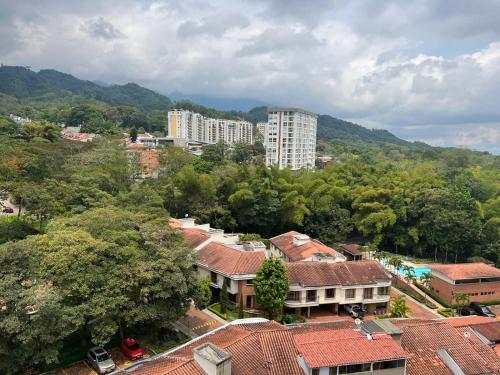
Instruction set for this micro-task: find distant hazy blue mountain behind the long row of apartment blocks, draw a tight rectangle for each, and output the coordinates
[169,91,268,112]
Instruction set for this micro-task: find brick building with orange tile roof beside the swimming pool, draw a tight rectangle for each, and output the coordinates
[429,262,500,304]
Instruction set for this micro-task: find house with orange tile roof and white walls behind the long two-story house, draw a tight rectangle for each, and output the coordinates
[269,231,347,263]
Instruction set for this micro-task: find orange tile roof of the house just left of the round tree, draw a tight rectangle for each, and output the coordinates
[197,242,265,275]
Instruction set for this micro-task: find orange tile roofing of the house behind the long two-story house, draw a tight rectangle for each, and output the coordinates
[270,231,343,262]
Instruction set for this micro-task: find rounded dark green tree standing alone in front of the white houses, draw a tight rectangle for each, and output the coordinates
[254,258,288,319]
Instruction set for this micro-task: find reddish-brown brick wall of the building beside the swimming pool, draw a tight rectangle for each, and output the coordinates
[430,274,500,304]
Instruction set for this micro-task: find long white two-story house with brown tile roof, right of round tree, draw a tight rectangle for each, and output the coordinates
[285,260,391,316]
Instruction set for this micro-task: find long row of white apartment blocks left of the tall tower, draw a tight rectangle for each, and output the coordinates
[168,109,254,145]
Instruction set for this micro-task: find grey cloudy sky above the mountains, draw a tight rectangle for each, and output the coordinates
[0,0,500,154]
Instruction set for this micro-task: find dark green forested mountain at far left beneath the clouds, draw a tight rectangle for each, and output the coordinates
[0,65,172,110]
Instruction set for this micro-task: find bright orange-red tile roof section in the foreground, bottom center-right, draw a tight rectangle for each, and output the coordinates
[294,329,409,368]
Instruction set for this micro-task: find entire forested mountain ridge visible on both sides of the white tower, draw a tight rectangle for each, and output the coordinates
[0,66,422,147]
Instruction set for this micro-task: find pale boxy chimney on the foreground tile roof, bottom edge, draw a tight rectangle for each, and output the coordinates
[193,342,231,375]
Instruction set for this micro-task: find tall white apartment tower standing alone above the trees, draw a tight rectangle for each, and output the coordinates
[264,108,317,170]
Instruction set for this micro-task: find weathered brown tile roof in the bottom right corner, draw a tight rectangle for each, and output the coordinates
[400,320,500,375]
